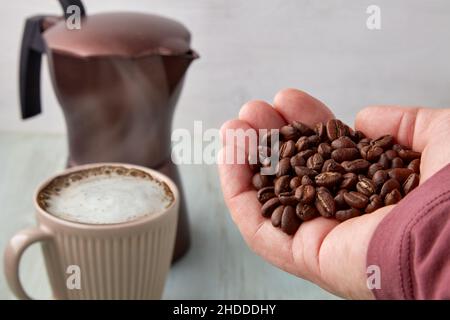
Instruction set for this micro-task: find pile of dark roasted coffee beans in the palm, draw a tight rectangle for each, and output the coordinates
[250,119,421,234]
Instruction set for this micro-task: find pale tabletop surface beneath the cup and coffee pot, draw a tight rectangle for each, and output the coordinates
[0,132,336,299]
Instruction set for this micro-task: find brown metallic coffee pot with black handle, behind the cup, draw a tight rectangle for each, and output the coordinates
[20,0,198,260]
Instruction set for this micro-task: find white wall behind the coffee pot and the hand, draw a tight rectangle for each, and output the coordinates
[0,0,450,132]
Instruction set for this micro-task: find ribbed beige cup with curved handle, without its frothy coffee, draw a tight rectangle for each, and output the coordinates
[4,163,179,299]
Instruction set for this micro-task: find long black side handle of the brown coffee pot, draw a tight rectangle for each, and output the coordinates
[19,16,45,119]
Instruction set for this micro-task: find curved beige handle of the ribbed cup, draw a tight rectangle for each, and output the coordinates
[5,227,52,300]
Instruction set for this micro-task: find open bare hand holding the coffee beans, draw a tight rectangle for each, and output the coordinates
[219,89,450,299]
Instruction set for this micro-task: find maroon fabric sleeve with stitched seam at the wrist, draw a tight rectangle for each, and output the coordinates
[367,164,450,299]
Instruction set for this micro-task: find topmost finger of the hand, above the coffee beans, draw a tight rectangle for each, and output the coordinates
[274,89,334,126]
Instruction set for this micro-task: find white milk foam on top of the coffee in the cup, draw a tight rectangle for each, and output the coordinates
[45,172,173,224]
